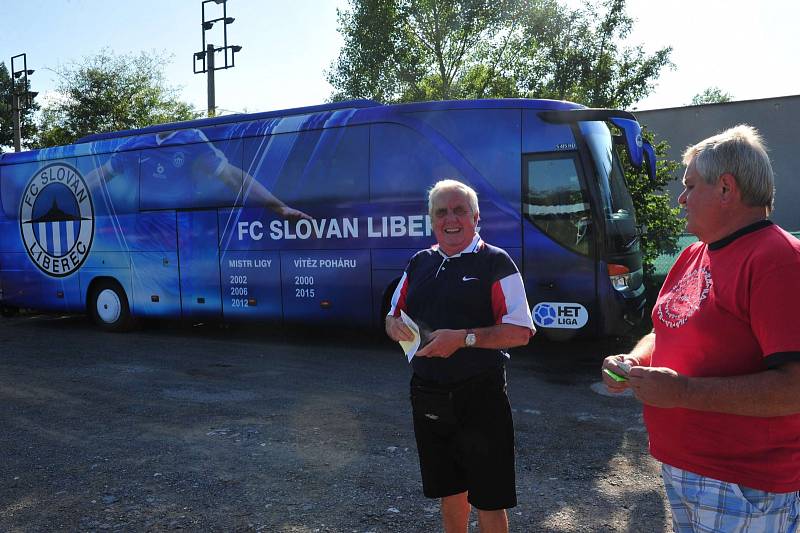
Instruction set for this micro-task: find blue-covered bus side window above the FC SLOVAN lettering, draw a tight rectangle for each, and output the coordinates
[244,126,369,207]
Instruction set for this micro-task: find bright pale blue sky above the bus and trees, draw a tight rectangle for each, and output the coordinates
[0,0,800,112]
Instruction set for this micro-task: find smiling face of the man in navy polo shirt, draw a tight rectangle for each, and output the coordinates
[431,189,479,255]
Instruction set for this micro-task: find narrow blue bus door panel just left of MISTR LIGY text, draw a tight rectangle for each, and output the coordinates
[177,210,222,319]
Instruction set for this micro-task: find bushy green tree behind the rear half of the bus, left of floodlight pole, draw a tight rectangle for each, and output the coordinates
[37,50,200,147]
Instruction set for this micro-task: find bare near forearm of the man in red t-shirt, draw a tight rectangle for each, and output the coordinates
[629,362,800,417]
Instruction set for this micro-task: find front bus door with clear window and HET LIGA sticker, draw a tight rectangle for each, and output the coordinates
[522,152,598,338]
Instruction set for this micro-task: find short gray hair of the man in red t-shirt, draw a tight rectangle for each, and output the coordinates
[683,124,775,213]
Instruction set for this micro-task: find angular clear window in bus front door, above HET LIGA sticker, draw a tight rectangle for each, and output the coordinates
[522,156,592,255]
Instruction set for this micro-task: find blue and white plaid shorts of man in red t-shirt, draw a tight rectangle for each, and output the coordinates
[661,464,800,533]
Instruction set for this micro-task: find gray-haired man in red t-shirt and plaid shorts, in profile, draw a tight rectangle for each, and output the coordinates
[603,125,800,532]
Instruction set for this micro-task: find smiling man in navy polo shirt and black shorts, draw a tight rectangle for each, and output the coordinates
[386,180,536,533]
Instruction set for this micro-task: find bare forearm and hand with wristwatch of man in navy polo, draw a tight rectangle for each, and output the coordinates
[416,324,531,357]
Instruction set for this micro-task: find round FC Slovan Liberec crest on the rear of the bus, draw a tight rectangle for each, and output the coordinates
[19,163,94,278]
